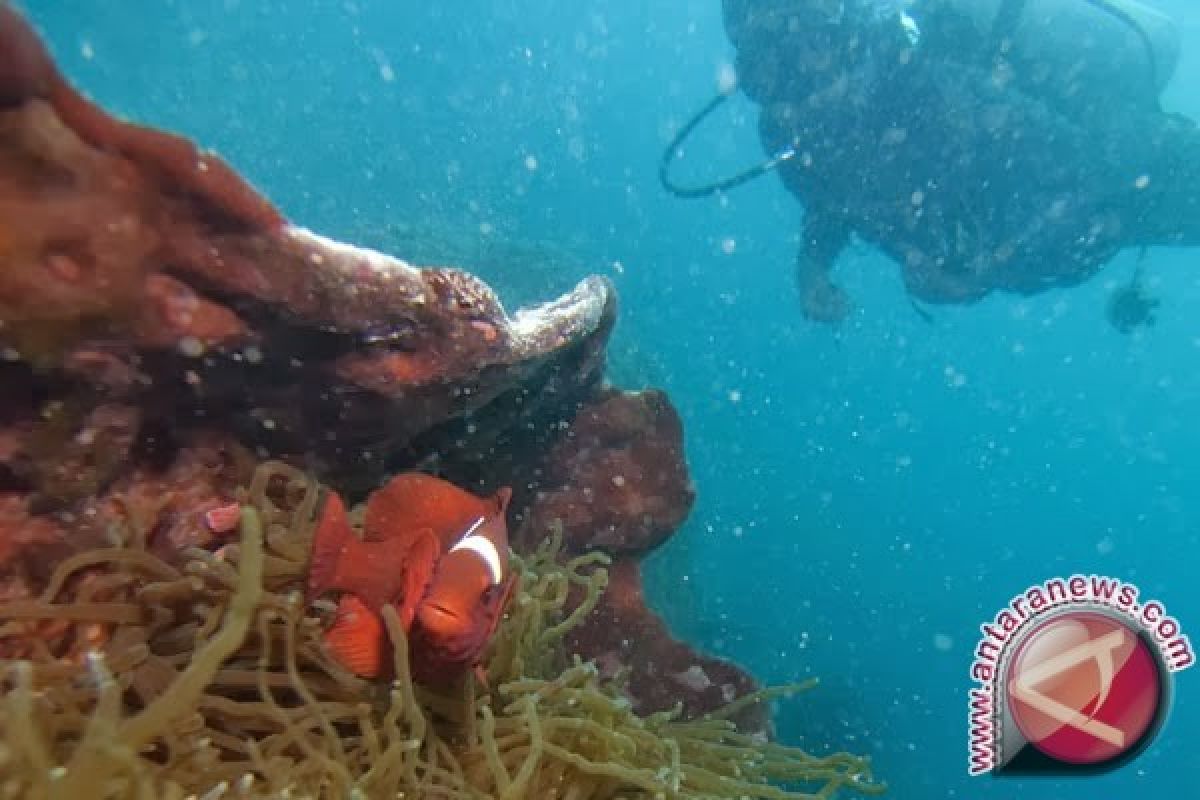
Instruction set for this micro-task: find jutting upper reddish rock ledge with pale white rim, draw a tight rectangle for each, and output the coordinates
[0,6,614,488]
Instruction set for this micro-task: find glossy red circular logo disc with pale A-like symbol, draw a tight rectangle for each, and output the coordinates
[1006,610,1165,766]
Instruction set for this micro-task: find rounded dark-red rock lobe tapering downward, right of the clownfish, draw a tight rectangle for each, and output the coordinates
[518,389,769,733]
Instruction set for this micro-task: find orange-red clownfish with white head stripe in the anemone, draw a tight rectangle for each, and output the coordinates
[307,473,514,682]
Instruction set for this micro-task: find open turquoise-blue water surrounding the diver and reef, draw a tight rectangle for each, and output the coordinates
[25,0,1200,800]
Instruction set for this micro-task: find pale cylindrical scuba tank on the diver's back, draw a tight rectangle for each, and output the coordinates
[911,0,1180,112]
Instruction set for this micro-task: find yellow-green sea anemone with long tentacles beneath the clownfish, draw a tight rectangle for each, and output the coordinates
[0,462,882,800]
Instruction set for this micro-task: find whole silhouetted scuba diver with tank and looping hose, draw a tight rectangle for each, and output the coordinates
[660,0,1200,323]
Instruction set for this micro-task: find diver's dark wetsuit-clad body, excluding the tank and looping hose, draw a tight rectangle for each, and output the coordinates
[725,0,1200,321]
